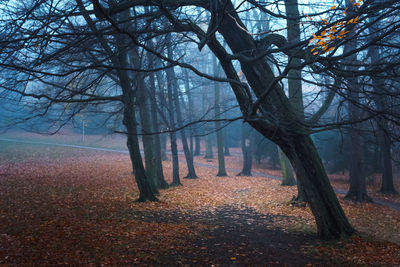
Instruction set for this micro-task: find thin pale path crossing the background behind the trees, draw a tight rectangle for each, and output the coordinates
[0,137,400,212]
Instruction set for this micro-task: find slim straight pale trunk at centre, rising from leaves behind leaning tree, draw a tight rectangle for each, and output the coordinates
[213,56,228,176]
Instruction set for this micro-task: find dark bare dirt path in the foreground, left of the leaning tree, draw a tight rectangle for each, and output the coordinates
[130,206,335,266]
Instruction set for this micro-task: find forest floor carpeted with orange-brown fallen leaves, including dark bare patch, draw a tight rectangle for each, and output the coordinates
[0,134,400,266]
